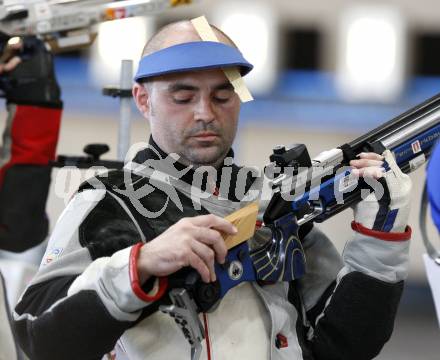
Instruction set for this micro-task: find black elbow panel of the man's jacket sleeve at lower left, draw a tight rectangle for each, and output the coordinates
[14,290,131,360]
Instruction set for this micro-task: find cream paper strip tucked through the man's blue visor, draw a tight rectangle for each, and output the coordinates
[191,16,254,102]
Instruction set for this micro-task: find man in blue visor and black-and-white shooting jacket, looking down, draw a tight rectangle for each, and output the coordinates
[14,21,410,360]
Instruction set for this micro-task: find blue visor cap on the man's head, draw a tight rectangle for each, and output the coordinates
[134,41,253,82]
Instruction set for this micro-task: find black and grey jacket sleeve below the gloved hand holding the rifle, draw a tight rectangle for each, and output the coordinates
[291,226,409,360]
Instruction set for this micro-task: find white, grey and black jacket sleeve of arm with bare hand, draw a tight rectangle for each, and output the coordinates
[14,190,160,360]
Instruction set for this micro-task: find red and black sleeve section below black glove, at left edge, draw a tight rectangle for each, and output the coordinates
[0,103,62,252]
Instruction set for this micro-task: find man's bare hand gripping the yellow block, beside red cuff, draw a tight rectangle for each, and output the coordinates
[137,214,237,284]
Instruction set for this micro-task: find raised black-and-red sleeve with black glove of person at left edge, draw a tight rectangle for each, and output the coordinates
[0,34,63,252]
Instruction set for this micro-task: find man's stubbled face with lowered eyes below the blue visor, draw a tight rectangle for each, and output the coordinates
[134,69,240,166]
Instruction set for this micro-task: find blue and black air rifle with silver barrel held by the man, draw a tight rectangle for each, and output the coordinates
[164,94,440,360]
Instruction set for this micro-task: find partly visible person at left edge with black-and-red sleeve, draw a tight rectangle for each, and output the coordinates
[0,33,62,359]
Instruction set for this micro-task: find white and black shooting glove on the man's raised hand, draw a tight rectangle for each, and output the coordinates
[352,150,411,236]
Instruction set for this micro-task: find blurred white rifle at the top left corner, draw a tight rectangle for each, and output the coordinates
[0,0,192,52]
